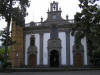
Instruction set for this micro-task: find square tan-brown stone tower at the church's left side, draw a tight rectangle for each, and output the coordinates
[9,21,24,67]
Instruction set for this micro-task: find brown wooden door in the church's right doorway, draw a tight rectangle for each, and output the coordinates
[75,53,83,67]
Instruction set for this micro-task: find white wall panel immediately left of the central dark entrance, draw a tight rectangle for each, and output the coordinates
[43,33,50,65]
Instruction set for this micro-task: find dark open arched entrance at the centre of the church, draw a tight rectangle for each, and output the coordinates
[50,50,59,67]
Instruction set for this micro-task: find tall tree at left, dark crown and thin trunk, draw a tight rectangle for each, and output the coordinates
[0,0,29,68]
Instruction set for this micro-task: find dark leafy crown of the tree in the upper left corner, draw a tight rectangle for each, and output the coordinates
[0,0,29,24]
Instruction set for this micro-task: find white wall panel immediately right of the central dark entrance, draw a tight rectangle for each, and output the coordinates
[59,32,66,65]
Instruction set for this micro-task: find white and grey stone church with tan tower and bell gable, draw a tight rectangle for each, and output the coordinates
[10,1,88,67]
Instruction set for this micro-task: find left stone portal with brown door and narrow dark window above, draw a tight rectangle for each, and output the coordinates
[28,35,37,67]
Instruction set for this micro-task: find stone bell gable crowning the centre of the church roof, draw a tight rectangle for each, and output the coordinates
[46,1,63,22]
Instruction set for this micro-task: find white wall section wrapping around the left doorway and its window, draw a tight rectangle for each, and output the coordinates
[25,34,40,65]
